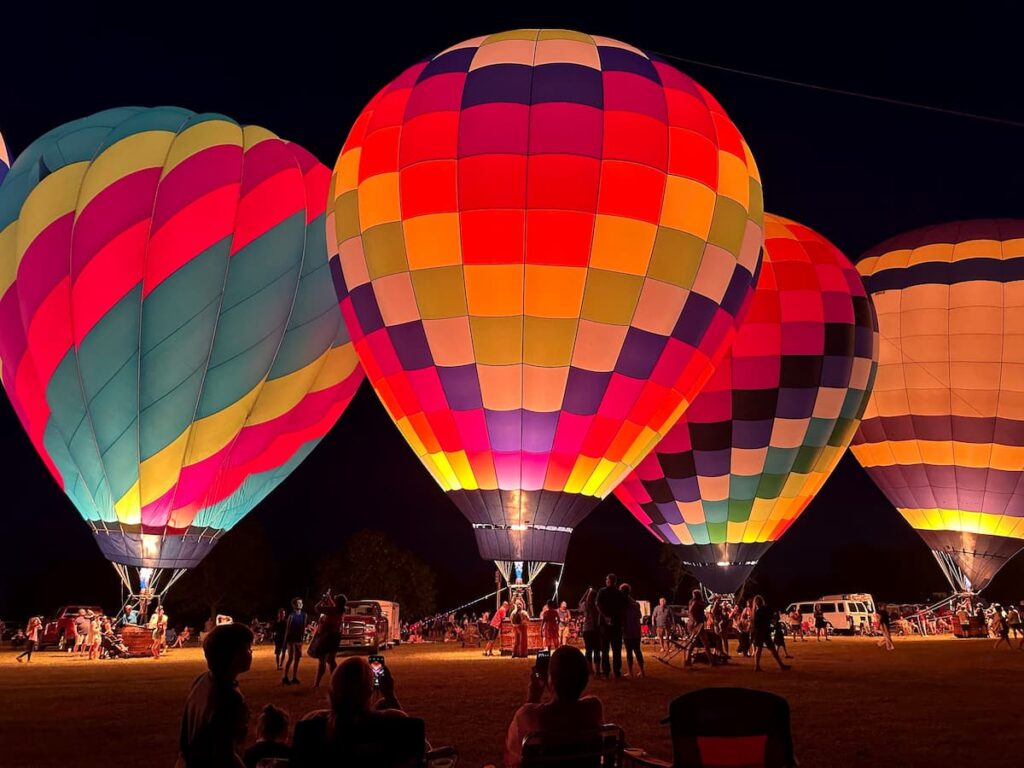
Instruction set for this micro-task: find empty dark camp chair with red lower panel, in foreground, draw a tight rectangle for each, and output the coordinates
[625,688,797,768]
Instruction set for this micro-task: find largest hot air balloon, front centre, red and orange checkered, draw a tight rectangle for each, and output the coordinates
[332,30,762,593]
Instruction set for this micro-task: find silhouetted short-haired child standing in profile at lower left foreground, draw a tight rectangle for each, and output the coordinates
[176,624,253,768]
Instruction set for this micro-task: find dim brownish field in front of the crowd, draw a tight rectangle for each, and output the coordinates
[0,638,1024,768]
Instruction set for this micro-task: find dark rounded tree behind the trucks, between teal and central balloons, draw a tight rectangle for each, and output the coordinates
[319,530,437,617]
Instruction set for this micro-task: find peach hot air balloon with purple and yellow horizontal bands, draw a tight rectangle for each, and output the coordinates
[852,220,1024,592]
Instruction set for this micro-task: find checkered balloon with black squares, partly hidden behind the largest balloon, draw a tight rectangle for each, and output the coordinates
[615,214,879,594]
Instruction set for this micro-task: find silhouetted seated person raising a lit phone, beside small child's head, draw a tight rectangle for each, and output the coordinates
[292,656,406,767]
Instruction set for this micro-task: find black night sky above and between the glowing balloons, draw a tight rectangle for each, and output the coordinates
[0,2,1024,618]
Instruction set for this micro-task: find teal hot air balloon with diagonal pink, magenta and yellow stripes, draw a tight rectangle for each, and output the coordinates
[0,108,361,591]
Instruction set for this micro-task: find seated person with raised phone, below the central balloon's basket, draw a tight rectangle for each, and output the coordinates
[505,645,604,768]
